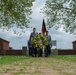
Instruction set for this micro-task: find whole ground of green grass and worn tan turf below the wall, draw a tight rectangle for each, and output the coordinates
[0,55,76,75]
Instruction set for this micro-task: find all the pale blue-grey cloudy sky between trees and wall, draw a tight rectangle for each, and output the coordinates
[0,0,76,49]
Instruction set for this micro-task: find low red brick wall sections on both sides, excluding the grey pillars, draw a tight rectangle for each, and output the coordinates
[0,50,76,55]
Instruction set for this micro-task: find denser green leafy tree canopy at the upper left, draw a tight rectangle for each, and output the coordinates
[0,0,35,29]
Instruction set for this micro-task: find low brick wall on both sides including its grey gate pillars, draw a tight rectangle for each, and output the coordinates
[0,47,76,55]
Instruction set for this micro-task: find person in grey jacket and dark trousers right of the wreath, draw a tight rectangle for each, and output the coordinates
[45,31,52,56]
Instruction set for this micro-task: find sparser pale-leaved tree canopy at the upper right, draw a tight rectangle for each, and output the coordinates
[42,0,76,33]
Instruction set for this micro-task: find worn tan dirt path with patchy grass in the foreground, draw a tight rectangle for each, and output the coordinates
[0,57,76,75]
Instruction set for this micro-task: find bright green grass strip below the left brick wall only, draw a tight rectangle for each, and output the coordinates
[0,56,30,66]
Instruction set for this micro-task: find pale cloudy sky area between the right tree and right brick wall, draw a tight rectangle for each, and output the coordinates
[49,28,76,49]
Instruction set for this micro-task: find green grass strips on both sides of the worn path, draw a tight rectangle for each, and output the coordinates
[0,55,76,66]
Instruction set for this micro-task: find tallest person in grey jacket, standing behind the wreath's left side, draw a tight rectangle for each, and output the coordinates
[30,28,38,57]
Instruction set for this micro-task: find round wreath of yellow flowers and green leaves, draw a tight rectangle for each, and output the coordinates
[32,35,47,49]
